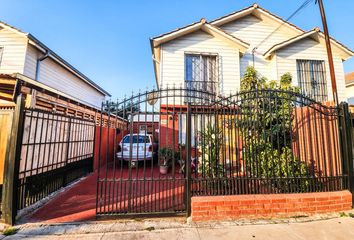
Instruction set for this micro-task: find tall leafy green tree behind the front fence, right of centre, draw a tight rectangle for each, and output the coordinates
[238,67,316,192]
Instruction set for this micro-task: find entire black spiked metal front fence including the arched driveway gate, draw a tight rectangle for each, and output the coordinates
[96,88,350,216]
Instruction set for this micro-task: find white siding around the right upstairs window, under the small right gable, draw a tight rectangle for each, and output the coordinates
[276,38,346,101]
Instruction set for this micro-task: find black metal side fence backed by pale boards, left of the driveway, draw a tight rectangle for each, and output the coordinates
[16,109,95,210]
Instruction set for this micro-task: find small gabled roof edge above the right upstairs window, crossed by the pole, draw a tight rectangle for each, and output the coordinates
[263,27,354,60]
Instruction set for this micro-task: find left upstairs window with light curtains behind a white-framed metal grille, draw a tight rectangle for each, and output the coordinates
[185,54,218,92]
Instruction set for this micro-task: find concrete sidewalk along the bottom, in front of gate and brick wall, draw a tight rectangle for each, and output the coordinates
[4,217,354,240]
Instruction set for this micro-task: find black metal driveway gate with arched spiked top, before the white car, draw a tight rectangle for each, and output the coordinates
[97,88,216,216]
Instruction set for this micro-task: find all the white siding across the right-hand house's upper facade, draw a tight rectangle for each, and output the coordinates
[159,15,346,101]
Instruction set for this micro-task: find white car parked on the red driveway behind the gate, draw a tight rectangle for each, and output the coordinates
[117,134,157,162]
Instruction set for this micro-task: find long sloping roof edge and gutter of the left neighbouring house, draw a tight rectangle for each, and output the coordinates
[0,21,111,97]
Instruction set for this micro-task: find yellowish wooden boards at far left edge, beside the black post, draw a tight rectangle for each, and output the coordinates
[0,106,14,184]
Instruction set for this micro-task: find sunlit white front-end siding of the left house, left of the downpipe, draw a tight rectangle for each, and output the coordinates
[0,28,27,74]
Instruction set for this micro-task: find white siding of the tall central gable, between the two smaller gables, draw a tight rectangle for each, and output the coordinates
[220,15,295,79]
